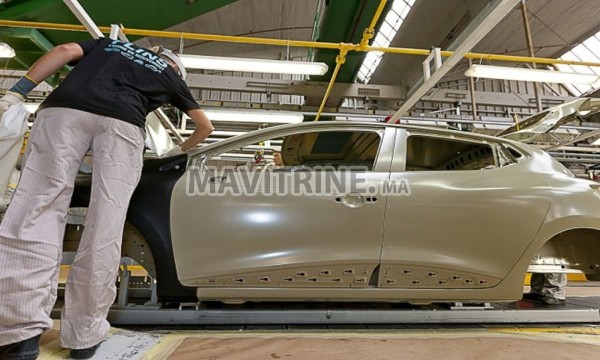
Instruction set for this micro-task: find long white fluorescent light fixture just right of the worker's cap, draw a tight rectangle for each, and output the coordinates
[179,54,328,75]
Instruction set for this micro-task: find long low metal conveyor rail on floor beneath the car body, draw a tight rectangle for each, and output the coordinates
[51,276,600,326]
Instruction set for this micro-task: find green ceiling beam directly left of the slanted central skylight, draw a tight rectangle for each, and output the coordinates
[311,0,393,83]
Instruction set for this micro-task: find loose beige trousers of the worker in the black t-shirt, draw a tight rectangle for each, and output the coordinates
[0,108,145,349]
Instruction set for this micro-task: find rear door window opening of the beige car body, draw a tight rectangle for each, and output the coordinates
[406,135,496,171]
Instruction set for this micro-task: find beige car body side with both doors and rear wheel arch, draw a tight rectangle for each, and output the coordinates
[171,122,600,303]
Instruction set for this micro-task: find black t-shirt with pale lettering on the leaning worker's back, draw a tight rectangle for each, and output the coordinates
[40,38,199,127]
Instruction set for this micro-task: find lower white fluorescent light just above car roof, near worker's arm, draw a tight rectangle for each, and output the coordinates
[203,109,304,124]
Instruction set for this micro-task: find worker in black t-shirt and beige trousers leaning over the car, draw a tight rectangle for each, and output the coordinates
[0,38,213,360]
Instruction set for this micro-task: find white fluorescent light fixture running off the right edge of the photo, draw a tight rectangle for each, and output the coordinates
[465,65,600,84]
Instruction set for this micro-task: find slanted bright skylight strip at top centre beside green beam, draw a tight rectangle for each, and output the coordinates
[358,0,416,84]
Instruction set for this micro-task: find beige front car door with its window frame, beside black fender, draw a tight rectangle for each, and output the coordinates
[171,125,395,288]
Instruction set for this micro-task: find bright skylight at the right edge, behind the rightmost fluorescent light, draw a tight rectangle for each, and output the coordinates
[556,32,600,96]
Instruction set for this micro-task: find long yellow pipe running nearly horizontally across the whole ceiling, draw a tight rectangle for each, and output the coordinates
[0,20,600,67]
